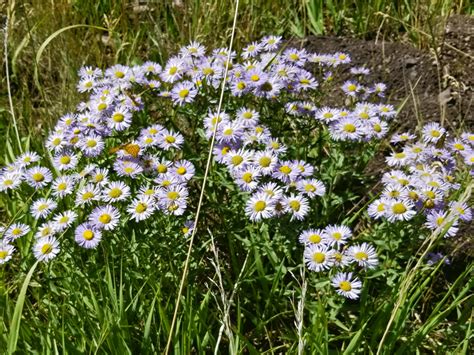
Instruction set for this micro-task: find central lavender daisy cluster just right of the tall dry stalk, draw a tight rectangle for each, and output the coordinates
[205,107,326,221]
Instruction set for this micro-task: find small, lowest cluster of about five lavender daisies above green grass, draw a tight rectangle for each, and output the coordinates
[299,225,378,299]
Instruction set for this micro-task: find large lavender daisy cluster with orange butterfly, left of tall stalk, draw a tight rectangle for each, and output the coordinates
[0,63,195,263]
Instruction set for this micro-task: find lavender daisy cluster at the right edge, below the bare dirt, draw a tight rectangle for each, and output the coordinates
[368,122,474,237]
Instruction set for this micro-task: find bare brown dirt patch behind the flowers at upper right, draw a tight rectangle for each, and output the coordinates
[293,15,474,130]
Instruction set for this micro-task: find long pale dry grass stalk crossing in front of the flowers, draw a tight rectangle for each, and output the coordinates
[165,0,243,354]
